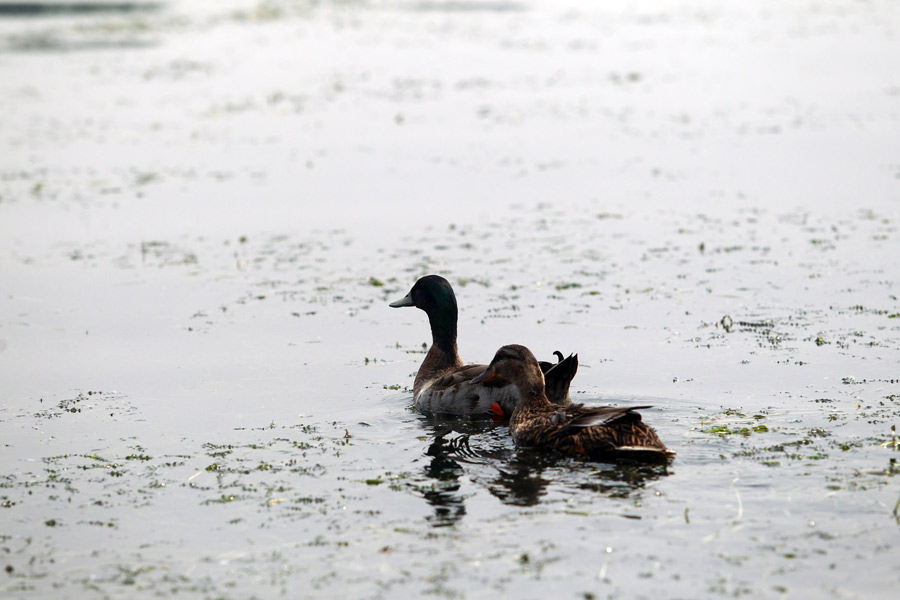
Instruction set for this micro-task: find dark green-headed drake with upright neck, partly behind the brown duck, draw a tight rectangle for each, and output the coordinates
[390,275,578,415]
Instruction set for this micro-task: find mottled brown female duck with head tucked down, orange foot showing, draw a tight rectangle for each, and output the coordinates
[469,345,675,462]
